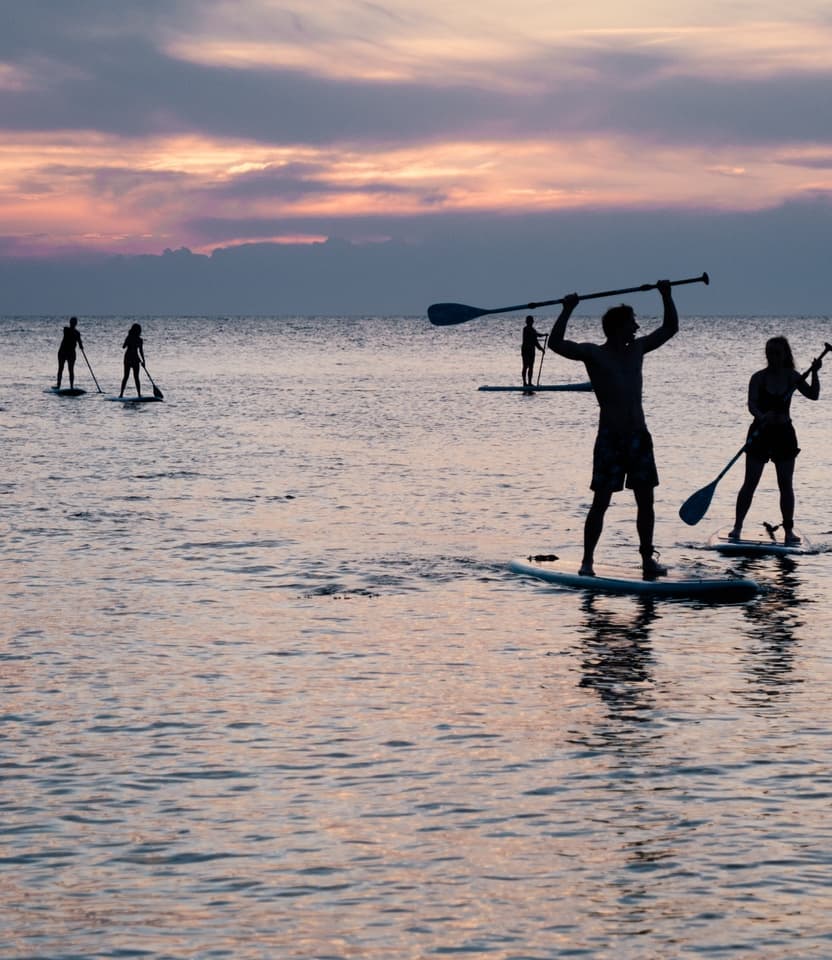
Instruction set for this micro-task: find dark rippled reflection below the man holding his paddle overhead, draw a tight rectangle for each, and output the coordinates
[580,594,659,722]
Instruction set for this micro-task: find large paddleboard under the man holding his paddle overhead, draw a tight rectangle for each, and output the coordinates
[509,554,760,603]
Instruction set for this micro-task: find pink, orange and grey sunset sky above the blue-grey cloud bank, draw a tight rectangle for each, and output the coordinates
[0,0,832,310]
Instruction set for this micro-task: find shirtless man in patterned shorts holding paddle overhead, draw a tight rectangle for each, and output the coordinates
[549,280,679,580]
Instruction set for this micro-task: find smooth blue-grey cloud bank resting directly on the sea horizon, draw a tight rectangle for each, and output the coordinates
[0,197,832,316]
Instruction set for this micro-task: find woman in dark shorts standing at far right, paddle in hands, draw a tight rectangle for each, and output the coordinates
[728,337,823,546]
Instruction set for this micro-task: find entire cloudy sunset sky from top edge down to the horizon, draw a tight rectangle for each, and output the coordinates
[0,0,832,315]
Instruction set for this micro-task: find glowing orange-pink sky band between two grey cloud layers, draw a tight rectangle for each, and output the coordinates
[0,128,832,252]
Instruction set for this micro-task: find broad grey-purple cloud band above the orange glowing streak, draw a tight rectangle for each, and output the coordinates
[0,0,832,152]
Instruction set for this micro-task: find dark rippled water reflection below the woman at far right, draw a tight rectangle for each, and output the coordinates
[738,556,805,704]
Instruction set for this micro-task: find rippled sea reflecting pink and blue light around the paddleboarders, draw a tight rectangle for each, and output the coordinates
[0,312,832,960]
